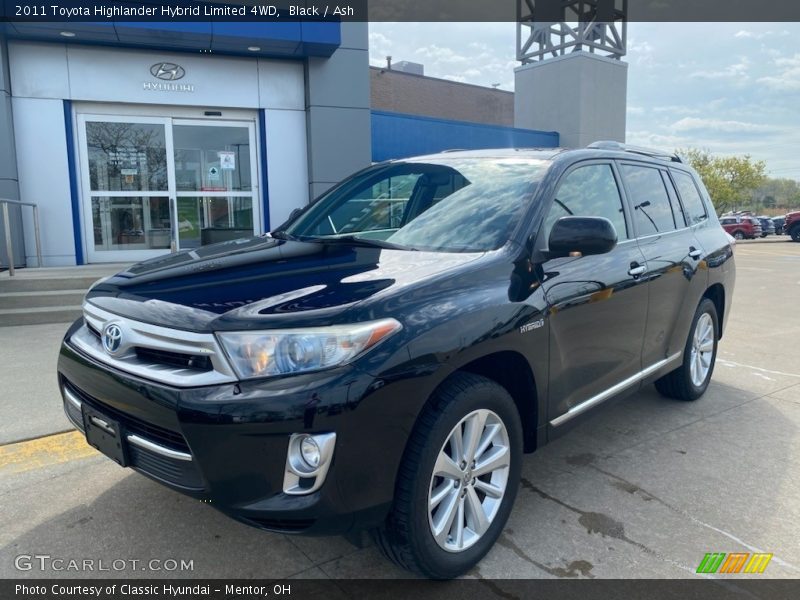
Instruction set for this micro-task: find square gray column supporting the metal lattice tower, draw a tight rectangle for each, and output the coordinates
[514,52,628,148]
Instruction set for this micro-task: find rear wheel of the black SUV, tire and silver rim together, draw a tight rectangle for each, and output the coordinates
[655,298,719,401]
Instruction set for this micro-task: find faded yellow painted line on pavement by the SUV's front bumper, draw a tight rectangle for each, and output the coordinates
[0,431,97,474]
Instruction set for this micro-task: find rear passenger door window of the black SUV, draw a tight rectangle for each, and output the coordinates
[622,165,676,236]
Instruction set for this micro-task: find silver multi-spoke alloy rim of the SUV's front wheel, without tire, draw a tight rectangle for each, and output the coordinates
[428,409,511,552]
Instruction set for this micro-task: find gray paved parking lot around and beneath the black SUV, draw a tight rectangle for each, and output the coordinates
[0,237,800,578]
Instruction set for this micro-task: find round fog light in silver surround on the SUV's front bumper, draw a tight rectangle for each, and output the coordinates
[283,433,336,495]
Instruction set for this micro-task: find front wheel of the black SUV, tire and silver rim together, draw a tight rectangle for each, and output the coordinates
[375,373,522,579]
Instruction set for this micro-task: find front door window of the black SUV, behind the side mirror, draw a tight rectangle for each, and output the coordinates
[544,165,630,240]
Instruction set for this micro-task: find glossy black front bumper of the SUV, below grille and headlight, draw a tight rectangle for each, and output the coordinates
[58,323,400,535]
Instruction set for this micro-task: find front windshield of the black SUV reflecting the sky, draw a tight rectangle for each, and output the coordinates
[284,158,550,252]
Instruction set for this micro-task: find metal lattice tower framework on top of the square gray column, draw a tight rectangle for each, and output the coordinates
[517,0,628,64]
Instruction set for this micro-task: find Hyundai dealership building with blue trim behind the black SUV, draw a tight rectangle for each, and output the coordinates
[0,15,625,266]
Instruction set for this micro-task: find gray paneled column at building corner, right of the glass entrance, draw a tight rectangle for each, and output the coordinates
[306,23,372,198]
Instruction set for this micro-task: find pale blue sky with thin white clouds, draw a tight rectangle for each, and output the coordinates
[369,23,800,180]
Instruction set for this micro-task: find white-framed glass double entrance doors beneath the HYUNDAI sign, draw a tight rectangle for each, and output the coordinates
[79,115,260,262]
